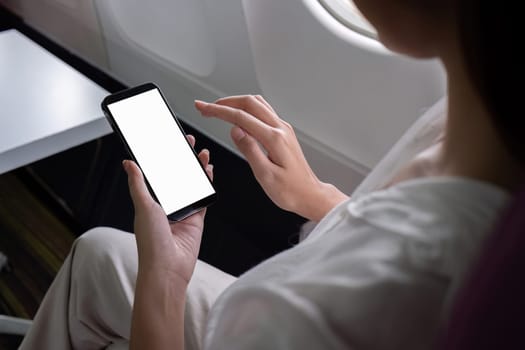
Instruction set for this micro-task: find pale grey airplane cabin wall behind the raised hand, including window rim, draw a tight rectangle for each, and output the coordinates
[0,0,445,192]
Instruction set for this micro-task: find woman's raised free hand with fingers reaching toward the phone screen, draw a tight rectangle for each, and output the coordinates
[195,95,348,221]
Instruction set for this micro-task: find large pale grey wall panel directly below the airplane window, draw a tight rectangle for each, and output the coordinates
[243,0,444,167]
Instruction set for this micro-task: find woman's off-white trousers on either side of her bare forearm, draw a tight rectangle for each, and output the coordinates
[20,227,235,350]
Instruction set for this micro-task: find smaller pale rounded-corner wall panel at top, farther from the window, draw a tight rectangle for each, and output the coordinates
[107,0,215,76]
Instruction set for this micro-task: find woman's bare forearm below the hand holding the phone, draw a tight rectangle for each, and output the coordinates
[130,268,187,350]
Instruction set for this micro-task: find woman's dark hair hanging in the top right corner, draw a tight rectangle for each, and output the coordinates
[459,0,525,164]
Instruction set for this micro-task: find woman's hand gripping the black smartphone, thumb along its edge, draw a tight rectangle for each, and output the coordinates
[123,135,213,283]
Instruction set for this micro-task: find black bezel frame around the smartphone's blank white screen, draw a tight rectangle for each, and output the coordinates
[101,83,217,221]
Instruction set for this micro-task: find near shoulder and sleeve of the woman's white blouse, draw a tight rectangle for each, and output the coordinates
[205,177,508,350]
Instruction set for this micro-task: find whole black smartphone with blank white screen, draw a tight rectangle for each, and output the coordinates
[102,83,217,221]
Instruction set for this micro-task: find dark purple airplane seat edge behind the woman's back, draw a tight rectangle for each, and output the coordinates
[439,186,525,350]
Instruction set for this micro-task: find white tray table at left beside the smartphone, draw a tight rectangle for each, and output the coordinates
[0,29,111,174]
